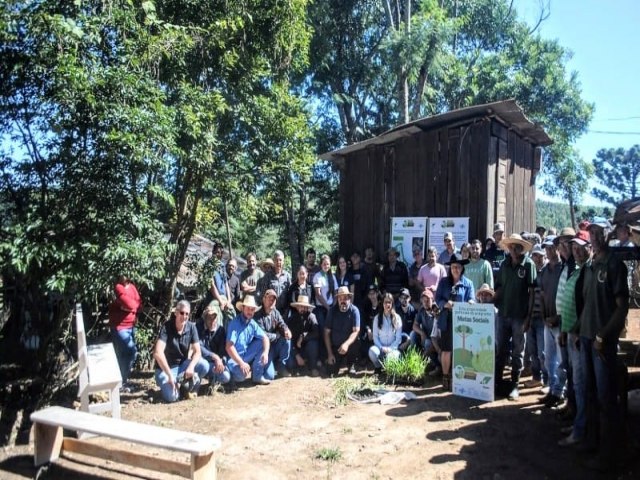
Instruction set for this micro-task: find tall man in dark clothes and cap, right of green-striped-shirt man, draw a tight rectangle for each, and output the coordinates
[576,222,629,471]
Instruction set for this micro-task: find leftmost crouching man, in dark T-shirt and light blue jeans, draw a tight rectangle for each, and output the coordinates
[153,300,209,402]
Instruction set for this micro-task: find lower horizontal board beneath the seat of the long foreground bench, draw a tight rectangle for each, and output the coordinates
[62,438,191,478]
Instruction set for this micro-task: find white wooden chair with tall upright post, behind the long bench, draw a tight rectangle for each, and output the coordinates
[76,303,122,418]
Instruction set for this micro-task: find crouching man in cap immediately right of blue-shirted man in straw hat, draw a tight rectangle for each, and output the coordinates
[255,289,291,378]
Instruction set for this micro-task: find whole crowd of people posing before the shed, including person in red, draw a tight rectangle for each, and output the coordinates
[112,222,629,468]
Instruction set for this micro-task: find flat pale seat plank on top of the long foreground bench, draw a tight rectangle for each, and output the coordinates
[31,407,220,456]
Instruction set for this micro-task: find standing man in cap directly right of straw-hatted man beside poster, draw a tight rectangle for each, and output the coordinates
[524,245,548,388]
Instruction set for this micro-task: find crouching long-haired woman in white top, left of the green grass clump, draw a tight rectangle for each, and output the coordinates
[369,293,402,373]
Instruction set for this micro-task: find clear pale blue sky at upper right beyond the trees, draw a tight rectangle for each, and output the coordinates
[515,0,640,205]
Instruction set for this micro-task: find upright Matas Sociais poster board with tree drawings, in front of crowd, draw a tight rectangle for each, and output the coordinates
[451,302,496,402]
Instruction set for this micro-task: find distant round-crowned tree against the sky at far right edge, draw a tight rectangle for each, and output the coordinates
[593,145,640,206]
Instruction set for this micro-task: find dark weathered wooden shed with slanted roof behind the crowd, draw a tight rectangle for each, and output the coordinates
[321,100,552,253]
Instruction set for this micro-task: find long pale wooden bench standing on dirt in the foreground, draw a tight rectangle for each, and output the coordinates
[31,407,220,479]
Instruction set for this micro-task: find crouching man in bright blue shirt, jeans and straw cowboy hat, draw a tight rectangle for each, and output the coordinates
[226,295,275,385]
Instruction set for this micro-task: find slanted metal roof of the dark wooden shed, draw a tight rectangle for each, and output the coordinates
[320,100,553,161]
